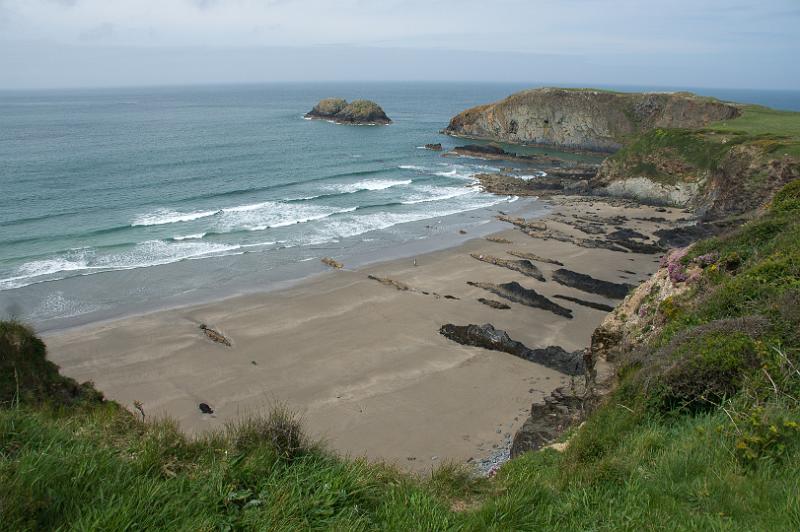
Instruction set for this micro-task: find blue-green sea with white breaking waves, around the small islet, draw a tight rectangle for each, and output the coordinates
[0,83,800,331]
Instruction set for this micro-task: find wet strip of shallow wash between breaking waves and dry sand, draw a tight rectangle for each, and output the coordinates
[21,195,536,335]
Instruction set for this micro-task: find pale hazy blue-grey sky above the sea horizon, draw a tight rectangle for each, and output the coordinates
[0,0,800,89]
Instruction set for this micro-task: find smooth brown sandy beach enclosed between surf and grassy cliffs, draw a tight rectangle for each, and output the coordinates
[45,198,686,472]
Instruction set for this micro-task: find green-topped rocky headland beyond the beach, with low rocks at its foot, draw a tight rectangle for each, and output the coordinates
[444,88,800,220]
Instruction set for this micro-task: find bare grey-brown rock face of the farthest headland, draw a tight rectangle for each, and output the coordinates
[445,88,740,152]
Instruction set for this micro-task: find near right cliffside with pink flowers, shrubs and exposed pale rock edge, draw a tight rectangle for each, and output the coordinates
[511,179,800,467]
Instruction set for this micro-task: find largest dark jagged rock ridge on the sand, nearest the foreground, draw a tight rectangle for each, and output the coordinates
[439,323,584,375]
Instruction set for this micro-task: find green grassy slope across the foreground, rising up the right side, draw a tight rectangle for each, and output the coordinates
[0,180,800,530]
